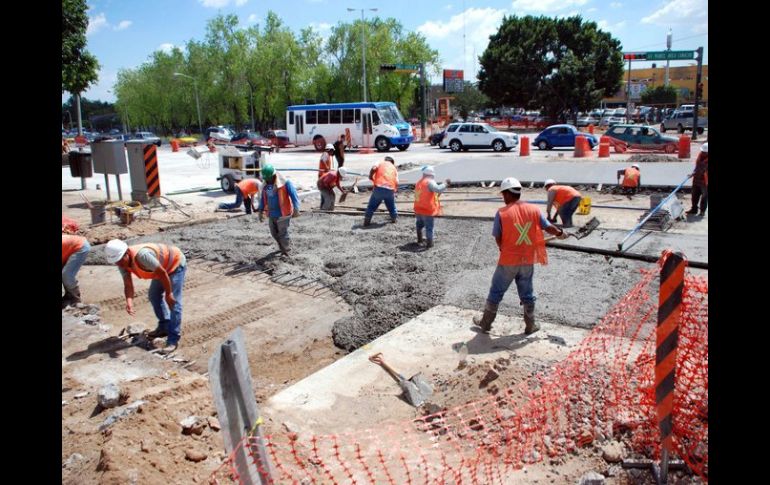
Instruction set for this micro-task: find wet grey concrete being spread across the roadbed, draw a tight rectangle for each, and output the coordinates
[88,213,672,350]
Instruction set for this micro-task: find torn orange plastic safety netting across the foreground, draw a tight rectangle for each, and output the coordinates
[211,255,708,484]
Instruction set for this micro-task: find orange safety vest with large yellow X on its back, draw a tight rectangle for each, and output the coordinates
[497,200,548,266]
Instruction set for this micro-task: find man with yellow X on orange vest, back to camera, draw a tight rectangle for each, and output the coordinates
[473,177,567,335]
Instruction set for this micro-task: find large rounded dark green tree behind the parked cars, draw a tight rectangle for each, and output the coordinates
[478,15,623,118]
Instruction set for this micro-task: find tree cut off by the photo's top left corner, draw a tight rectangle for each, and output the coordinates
[61,0,99,132]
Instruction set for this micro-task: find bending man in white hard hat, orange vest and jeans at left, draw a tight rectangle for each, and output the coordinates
[104,239,187,354]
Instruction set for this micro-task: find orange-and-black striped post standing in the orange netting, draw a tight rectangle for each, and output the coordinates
[655,251,686,483]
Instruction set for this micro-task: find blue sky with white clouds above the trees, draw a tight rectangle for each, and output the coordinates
[69,0,708,102]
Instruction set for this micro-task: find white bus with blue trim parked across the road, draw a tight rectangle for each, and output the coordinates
[286,102,414,152]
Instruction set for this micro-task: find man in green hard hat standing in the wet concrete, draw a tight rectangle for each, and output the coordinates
[257,164,299,256]
